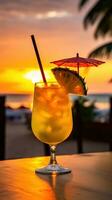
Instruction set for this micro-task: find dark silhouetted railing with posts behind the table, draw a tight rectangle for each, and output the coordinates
[0,96,112,160]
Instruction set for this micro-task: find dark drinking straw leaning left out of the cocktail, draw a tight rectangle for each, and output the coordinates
[31,35,47,85]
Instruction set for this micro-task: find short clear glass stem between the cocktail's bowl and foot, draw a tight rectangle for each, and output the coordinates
[49,145,57,165]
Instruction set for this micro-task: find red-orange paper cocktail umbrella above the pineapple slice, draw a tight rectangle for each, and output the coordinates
[51,53,105,74]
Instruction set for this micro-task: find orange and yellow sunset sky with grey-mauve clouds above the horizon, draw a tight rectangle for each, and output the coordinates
[0,0,112,93]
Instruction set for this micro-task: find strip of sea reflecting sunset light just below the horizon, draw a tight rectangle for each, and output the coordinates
[6,93,112,110]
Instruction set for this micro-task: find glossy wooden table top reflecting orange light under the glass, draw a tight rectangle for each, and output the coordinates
[0,152,112,200]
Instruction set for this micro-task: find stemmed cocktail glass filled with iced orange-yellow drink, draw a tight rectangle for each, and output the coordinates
[32,83,72,174]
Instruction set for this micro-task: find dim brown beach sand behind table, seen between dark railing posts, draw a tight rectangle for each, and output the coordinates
[5,121,109,159]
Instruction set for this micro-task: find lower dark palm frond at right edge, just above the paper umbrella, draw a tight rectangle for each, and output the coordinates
[88,42,112,58]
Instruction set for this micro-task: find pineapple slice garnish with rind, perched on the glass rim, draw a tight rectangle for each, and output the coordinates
[52,67,87,95]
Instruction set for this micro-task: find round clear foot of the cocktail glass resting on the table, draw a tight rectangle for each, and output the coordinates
[35,164,71,174]
